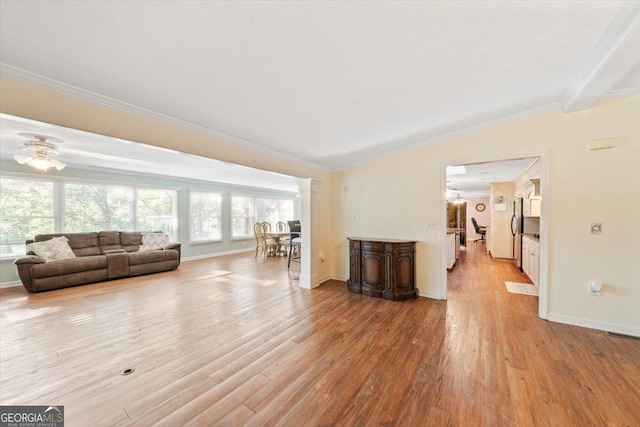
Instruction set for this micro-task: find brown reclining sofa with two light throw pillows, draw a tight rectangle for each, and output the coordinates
[15,231,181,292]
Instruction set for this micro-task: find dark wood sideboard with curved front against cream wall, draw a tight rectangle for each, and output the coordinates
[347,237,418,301]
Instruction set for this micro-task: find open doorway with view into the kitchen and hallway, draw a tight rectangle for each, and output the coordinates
[441,153,548,318]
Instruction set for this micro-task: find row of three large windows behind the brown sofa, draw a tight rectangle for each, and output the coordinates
[0,175,177,257]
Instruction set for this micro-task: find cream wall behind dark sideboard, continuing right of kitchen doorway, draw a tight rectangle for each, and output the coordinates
[332,97,640,335]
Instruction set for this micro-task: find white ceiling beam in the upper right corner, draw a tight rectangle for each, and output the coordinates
[560,1,640,113]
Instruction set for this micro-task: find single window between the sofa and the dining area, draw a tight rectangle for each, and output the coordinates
[189,191,222,242]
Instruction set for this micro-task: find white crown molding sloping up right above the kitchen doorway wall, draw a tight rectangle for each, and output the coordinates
[334,102,560,171]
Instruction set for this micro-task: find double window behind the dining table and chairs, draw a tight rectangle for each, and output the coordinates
[231,196,293,238]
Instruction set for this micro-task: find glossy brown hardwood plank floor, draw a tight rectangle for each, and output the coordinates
[0,243,640,426]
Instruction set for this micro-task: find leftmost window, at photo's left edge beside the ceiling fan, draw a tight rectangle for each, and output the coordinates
[0,177,56,256]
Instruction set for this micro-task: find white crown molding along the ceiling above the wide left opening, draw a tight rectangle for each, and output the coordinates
[0,63,331,173]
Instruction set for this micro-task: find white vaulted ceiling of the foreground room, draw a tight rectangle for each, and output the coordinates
[0,0,640,176]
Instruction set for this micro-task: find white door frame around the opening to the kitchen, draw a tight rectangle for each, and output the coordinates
[440,151,550,319]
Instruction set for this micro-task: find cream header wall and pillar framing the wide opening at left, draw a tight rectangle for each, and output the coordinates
[0,78,333,290]
